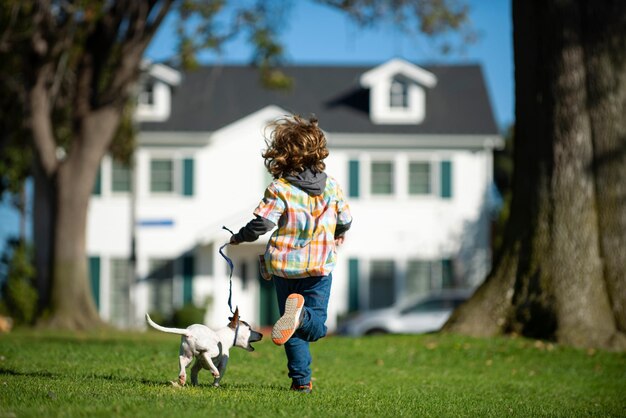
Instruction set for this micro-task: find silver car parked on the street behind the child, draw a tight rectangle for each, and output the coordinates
[337,289,473,336]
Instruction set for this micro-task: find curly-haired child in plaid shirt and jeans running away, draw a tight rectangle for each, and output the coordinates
[230,116,352,393]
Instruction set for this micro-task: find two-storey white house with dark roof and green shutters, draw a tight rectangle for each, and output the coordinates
[87,59,503,330]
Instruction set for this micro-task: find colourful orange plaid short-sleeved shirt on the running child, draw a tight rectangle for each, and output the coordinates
[254,177,352,279]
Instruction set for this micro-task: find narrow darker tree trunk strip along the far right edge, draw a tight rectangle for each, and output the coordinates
[585,2,626,332]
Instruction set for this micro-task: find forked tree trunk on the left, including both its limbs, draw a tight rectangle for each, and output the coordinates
[30,62,122,329]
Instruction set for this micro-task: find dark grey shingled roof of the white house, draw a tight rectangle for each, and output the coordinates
[141,65,498,135]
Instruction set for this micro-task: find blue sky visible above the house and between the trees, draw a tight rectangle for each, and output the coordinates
[0,0,514,251]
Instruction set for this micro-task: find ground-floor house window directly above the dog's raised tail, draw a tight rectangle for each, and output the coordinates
[148,258,174,315]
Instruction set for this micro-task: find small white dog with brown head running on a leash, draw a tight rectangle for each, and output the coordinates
[146,308,263,387]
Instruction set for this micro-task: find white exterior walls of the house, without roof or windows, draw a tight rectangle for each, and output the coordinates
[87,107,492,330]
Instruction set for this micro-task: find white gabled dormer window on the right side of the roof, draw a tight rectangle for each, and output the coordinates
[360,59,437,125]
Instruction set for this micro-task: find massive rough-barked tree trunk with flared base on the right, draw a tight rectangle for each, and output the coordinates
[444,0,626,348]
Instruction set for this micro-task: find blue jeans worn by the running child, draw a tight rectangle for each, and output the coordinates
[274,274,333,386]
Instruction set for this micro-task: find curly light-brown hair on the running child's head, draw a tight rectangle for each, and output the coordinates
[262,115,328,179]
